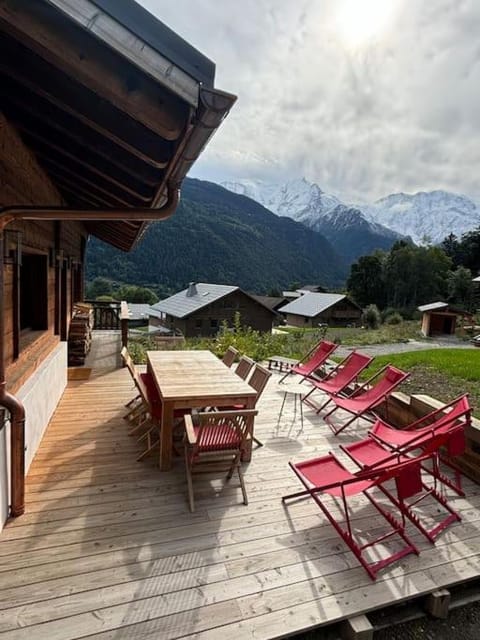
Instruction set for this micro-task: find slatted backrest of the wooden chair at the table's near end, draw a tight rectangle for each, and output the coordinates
[185,409,258,455]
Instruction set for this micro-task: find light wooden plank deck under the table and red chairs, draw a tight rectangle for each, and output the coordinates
[0,370,480,640]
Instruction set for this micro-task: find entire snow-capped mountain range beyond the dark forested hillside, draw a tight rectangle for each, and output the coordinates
[222,178,480,252]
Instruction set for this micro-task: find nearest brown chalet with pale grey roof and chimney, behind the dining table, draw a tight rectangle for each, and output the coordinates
[152,282,276,338]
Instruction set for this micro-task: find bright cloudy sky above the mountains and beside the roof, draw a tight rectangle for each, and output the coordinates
[139,0,480,202]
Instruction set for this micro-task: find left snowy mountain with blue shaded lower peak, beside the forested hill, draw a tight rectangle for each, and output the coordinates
[222,178,404,261]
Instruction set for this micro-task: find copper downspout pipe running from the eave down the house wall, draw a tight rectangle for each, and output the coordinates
[0,187,180,518]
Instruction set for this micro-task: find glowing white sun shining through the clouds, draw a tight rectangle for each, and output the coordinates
[334,0,396,49]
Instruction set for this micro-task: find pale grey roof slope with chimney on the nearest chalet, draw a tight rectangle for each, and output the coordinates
[152,282,238,318]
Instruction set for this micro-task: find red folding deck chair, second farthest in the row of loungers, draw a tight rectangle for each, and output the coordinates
[303,351,373,413]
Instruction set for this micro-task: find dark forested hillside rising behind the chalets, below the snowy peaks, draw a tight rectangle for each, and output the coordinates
[87,179,347,293]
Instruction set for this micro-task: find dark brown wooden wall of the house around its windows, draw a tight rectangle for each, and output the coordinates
[0,112,87,388]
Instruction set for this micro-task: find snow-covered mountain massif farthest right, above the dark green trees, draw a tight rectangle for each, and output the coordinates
[362,191,480,244]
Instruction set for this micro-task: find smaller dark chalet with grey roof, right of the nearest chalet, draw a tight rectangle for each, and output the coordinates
[279,292,362,327]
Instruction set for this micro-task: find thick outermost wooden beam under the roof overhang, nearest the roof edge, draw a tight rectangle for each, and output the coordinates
[0,0,189,140]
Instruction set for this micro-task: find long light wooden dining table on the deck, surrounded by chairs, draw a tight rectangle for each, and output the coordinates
[147,351,257,471]
